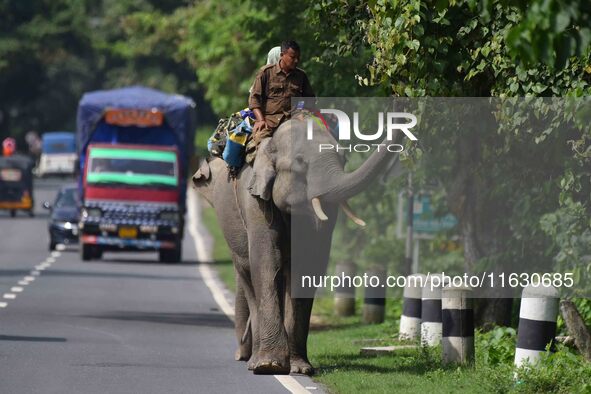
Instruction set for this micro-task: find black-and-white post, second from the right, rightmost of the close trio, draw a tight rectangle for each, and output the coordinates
[441,286,474,365]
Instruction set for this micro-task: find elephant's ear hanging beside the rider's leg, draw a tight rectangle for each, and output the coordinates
[248,138,276,201]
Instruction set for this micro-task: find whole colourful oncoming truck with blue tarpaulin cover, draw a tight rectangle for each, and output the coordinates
[77,87,195,263]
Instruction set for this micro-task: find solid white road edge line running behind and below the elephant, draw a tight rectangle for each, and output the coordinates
[187,188,316,394]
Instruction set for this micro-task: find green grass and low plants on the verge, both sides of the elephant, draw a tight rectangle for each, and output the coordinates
[197,185,591,394]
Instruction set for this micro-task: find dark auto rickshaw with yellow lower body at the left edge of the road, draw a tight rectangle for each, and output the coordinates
[0,154,35,217]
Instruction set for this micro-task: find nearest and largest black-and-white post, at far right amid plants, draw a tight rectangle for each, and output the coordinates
[515,285,560,367]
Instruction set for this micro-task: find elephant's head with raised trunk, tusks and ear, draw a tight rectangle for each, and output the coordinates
[249,119,398,225]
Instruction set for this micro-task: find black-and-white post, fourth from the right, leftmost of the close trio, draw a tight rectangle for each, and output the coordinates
[399,274,426,340]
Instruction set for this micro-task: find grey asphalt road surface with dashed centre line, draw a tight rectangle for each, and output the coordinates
[0,180,319,394]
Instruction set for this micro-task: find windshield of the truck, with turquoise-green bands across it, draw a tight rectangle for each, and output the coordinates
[86,148,178,187]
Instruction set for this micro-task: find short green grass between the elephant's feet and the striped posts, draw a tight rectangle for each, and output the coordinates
[308,299,511,393]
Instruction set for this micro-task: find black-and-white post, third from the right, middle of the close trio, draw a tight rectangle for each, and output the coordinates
[421,274,442,346]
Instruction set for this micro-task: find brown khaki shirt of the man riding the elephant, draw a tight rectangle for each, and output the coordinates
[248,63,314,128]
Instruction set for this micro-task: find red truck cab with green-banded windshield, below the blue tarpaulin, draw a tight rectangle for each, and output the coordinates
[80,144,183,262]
